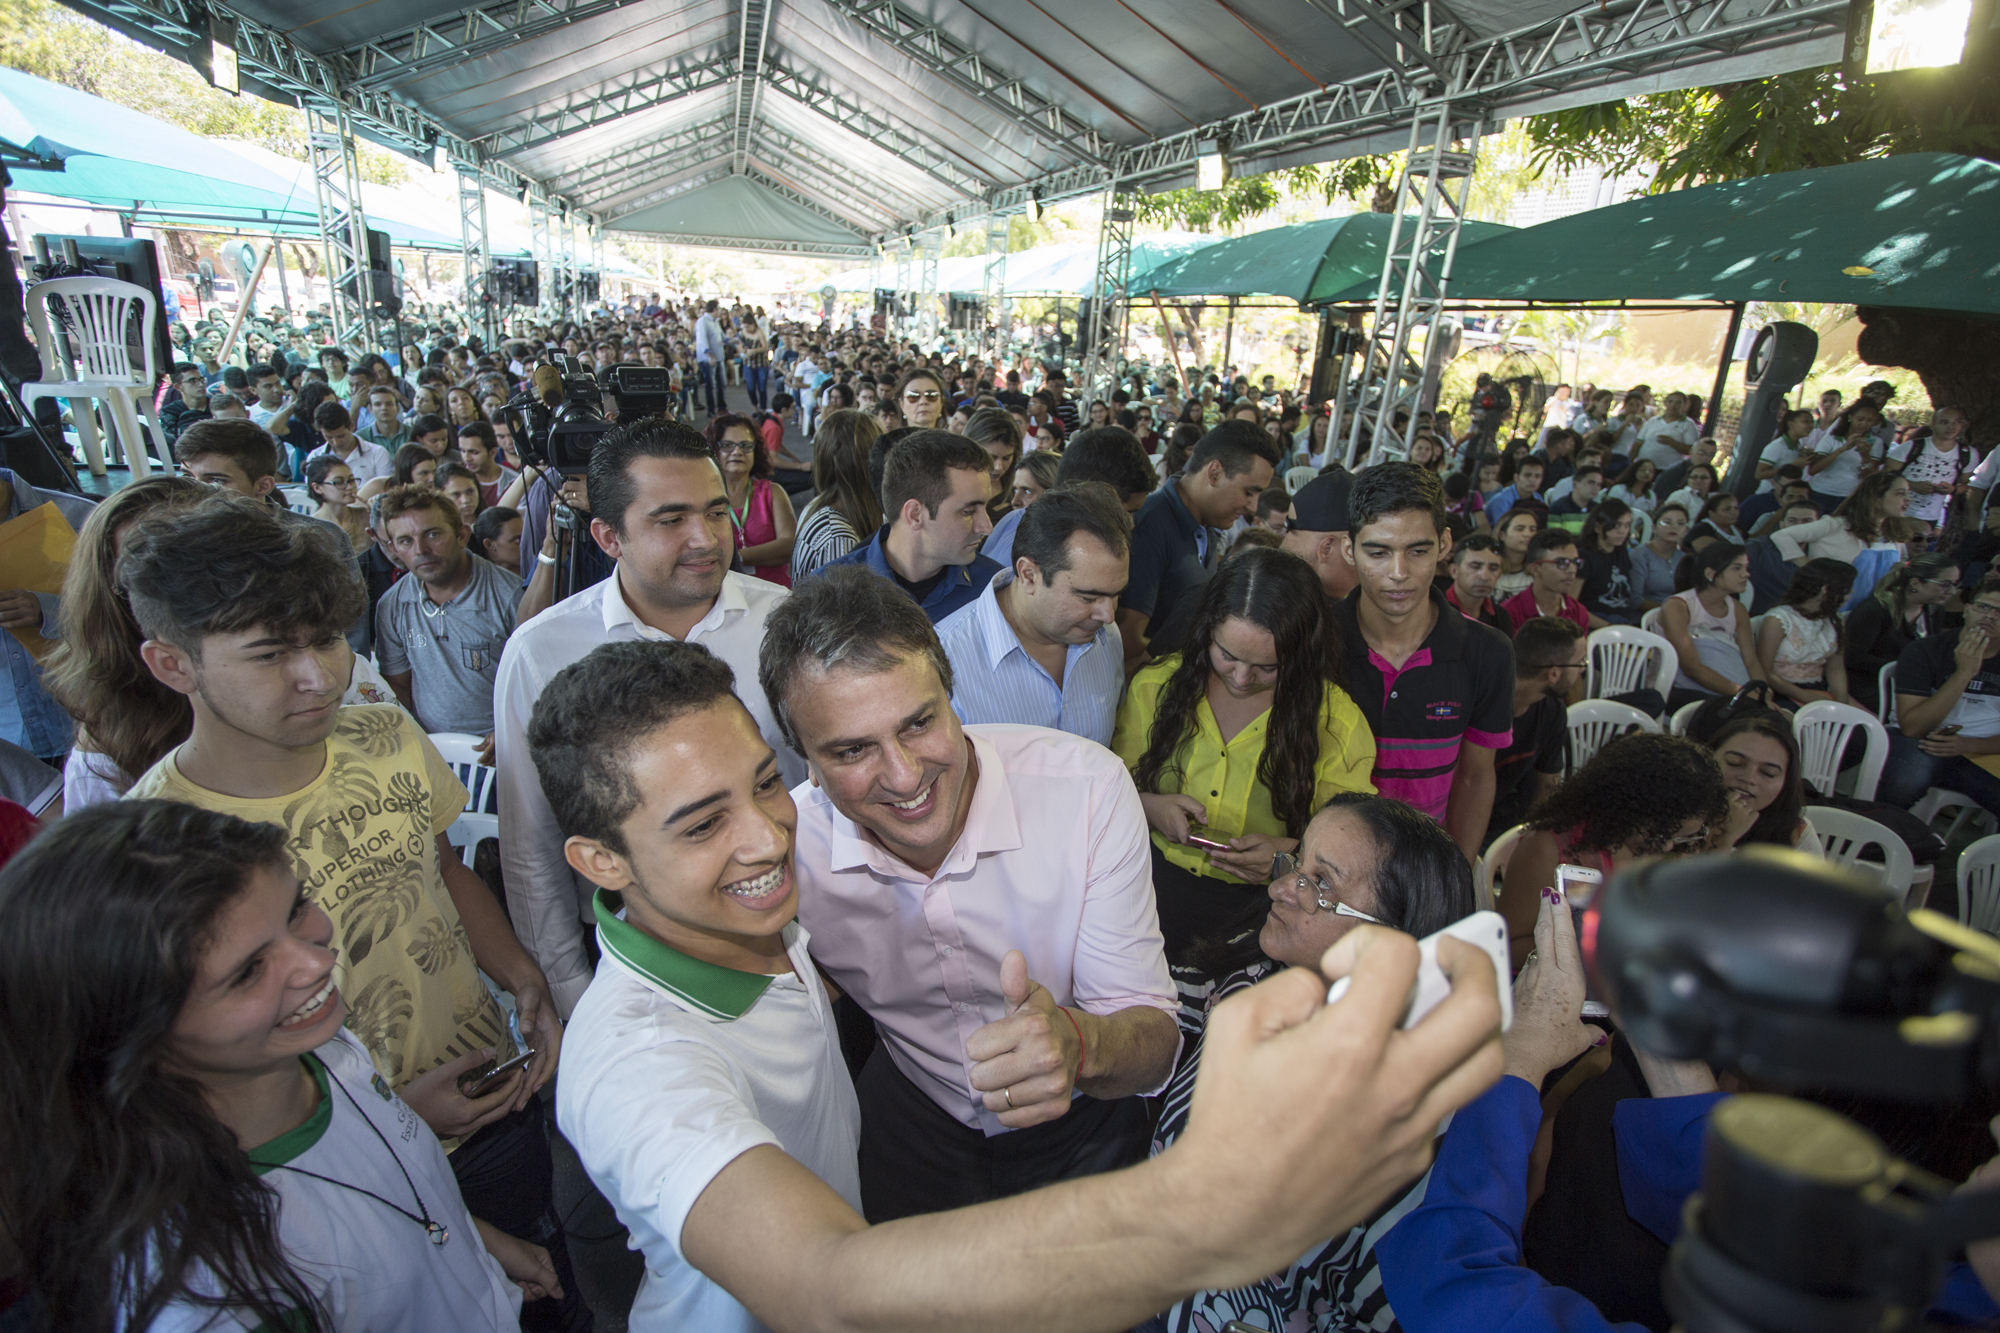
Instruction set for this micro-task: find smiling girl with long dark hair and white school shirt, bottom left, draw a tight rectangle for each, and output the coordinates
[0,801,556,1333]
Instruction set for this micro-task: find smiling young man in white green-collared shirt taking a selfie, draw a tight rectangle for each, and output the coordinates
[528,632,1502,1333]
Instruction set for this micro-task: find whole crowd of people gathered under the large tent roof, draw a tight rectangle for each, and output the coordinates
[0,300,2000,1333]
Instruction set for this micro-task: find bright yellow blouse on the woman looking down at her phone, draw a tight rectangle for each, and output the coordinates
[1112,654,1374,885]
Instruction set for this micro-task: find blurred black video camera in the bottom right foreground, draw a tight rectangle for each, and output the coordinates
[1578,849,2000,1333]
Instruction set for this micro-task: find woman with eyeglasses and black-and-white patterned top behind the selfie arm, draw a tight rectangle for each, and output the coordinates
[1140,791,1472,1333]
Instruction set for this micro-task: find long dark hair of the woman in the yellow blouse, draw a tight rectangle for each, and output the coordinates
[1136,544,1352,839]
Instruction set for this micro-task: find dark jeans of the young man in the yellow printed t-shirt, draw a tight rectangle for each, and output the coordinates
[450,1099,594,1333]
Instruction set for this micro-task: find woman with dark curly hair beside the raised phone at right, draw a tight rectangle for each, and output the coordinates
[1494,731,1730,971]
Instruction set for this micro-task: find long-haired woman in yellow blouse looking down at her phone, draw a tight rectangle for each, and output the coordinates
[1112,548,1374,963]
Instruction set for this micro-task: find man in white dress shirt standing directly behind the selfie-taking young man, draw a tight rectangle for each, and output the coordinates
[494,416,804,1017]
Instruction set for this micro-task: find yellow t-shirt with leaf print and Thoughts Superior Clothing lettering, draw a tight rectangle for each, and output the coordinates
[128,705,512,1089]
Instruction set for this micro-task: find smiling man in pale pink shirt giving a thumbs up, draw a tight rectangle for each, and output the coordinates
[758,568,1180,1221]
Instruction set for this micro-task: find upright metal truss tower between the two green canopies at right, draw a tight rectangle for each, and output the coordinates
[1334,102,1478,466]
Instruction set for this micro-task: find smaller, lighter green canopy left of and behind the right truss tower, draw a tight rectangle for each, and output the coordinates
[1132,212,1514,306]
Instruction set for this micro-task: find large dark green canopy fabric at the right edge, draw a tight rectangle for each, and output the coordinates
[1330,152,2000,316]
